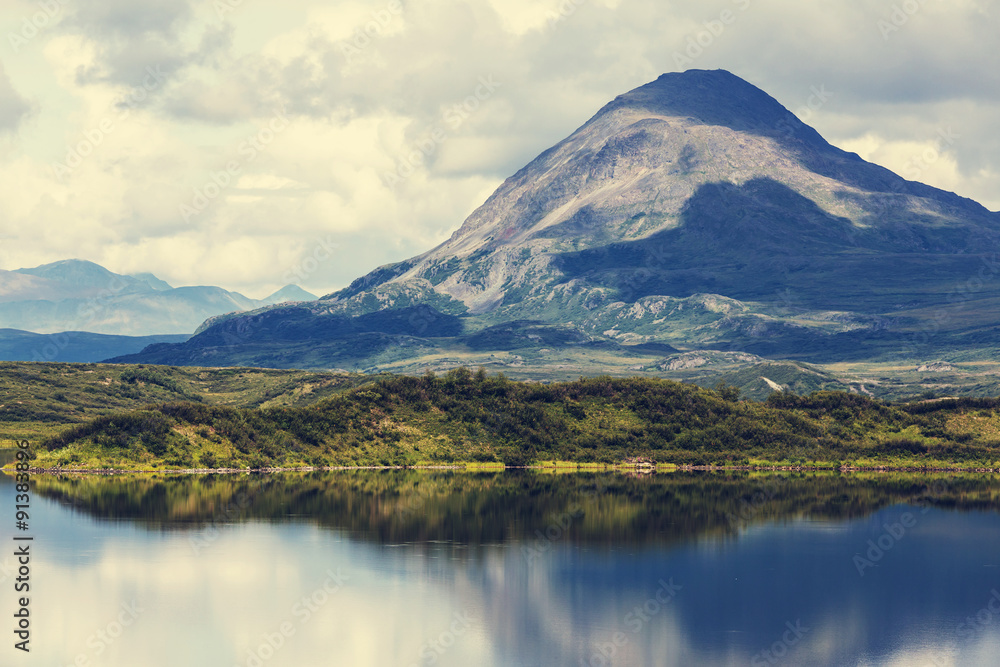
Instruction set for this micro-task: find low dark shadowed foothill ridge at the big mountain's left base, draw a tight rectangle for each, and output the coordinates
[107,305,677,377]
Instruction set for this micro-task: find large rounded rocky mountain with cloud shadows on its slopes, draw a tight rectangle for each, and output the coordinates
[109,70,1000,386]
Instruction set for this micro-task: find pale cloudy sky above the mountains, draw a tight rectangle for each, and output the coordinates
[0,0,1000,297]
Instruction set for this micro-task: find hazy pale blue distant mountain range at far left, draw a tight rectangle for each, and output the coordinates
[0,259,316,336]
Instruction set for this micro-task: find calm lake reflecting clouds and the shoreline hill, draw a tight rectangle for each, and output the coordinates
[0,471,1000,667]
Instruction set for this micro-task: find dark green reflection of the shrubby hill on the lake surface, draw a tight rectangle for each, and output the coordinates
[25,470,1000,546]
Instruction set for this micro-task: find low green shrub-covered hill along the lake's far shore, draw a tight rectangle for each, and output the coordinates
[11,368,1000,469]
